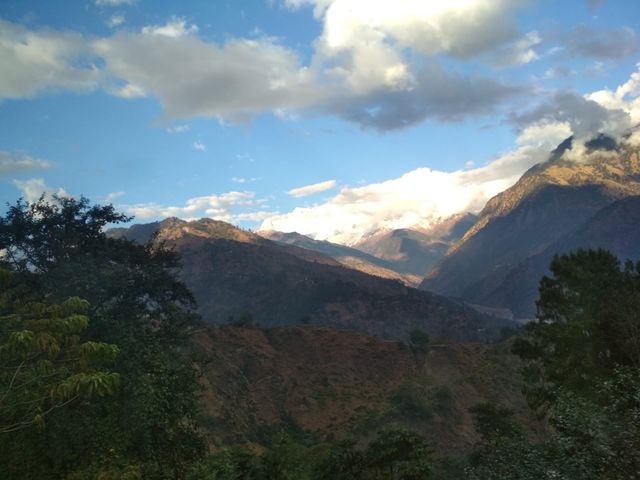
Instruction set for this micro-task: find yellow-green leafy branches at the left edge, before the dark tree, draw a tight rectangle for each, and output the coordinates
[0,269,120,436]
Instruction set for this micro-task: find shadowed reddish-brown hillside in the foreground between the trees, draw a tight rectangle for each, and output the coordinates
[194,326,532,454]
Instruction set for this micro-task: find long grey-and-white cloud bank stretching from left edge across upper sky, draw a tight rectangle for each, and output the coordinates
[0,0,539,131]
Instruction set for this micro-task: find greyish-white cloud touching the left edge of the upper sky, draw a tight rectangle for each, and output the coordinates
[0,19,100,98]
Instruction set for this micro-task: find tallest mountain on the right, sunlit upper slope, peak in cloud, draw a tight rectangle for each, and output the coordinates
[421,137,640,318]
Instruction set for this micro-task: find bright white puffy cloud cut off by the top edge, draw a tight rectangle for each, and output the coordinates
[304,0,525,58]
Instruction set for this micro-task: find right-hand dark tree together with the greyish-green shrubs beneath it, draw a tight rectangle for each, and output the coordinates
[468,250,640,480]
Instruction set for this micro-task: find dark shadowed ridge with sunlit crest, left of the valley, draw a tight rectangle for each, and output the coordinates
[110,218,508,340]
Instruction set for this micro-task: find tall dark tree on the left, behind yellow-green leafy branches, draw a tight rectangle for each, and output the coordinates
[0,197,204,479]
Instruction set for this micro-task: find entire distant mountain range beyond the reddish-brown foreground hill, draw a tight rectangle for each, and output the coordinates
[109,135,640,330]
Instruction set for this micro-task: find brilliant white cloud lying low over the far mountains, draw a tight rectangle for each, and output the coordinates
[260,123,571,244]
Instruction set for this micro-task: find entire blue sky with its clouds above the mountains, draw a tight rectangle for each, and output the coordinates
[0,0,640,244]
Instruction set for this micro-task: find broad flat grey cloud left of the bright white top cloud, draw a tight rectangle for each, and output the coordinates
[95,32,318,121]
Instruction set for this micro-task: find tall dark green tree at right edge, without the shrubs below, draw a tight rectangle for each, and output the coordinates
[514,250,640,406]
